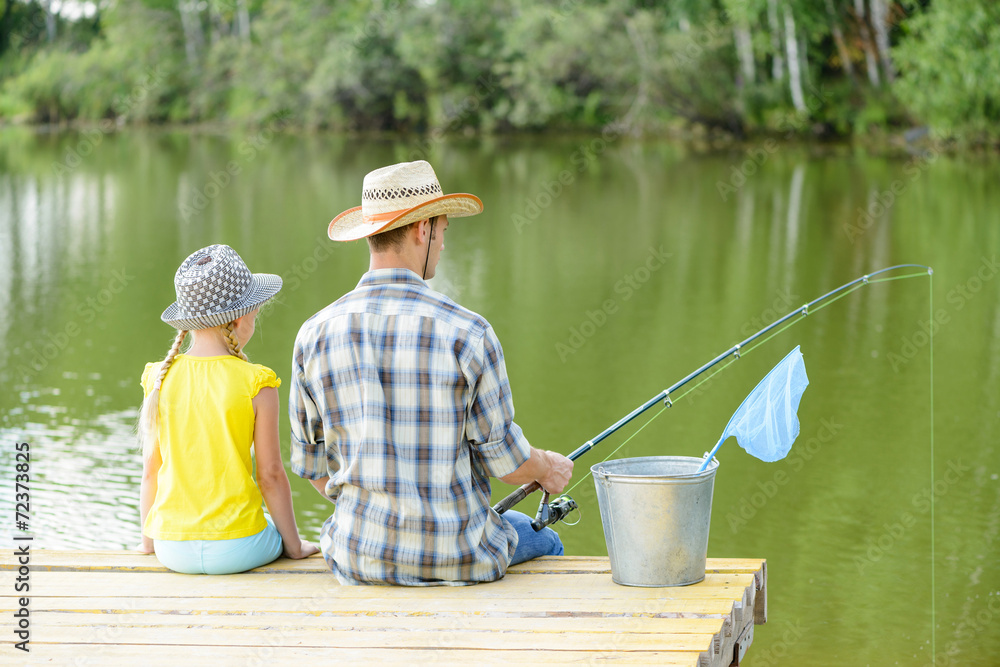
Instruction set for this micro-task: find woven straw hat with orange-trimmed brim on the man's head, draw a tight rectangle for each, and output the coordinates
[327,160,483,241]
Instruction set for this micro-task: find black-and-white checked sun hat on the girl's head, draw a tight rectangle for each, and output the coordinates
[160,244,281,331]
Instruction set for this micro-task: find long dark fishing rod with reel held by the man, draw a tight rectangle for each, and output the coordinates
[493,264,934,531]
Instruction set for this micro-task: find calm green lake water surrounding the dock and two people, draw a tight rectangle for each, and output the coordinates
[0,129,1000,667]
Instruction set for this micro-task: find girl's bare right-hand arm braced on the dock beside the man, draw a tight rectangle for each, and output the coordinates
[253,387,319,558]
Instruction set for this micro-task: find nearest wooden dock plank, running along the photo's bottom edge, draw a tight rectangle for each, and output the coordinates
[13,642,700,667]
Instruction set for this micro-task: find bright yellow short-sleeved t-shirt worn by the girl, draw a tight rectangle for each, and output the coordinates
[142,354,281,540]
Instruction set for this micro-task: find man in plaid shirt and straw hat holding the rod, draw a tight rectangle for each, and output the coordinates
[289,161,573,586]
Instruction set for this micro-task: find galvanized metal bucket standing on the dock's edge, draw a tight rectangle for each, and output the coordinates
[590,456,719,586]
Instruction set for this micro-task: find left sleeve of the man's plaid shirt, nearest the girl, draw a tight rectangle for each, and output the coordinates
[288,341,330,479]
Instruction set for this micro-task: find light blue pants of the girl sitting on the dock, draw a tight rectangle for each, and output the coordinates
[153,513,284,574]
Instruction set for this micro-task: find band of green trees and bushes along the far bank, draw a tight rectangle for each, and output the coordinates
[0,0,1000,142]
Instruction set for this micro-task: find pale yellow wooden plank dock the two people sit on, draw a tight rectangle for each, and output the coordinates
[0,551,767,667]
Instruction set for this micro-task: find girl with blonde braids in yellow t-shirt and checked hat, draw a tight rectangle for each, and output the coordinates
[138,245,317,574]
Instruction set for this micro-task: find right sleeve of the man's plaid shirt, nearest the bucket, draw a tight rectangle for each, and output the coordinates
[465,327,531,477]
